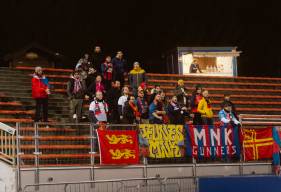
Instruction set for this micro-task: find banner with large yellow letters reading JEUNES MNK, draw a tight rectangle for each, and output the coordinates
[139,124,184,158]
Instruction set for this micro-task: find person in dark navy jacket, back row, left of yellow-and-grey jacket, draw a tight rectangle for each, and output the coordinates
[111,51,127,87]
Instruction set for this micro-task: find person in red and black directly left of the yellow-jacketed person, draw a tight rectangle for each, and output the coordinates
[190,85,202,125]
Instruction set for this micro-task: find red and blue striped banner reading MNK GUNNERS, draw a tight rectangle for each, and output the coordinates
[186,125,240,159]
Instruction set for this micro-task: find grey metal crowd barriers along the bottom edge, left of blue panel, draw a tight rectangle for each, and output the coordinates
[23,177,188,192]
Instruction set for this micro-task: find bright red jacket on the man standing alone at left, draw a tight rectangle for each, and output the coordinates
[31,76,48,99]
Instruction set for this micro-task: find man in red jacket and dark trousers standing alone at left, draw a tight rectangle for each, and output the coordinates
[31,67,50,122]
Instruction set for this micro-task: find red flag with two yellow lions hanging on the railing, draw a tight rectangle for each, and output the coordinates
[97,130,139,164]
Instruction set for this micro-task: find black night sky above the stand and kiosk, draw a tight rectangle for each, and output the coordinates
[0,0,281,77]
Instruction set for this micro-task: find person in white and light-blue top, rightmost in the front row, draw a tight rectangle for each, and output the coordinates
[219,103,240,125]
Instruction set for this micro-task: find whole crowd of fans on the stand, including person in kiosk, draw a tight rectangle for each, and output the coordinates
[32,46,240,125]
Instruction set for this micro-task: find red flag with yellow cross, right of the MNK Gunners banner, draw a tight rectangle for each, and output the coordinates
[242,128,274,160]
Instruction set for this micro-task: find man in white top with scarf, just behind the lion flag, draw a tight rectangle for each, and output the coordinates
[89,91,108,124]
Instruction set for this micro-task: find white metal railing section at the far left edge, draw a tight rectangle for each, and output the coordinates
[0,122,16,165]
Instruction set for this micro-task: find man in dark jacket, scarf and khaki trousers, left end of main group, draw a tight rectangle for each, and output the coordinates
[67,71,88,122]
